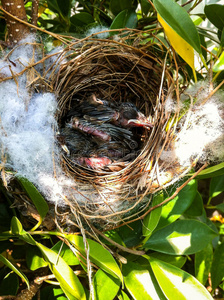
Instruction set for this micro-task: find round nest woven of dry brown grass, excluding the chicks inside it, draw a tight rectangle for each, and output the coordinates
[49,34,191,224]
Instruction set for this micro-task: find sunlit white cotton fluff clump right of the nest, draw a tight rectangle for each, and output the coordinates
[161,81,224,167]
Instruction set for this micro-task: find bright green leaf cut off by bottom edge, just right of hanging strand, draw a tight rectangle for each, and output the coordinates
[93,269,120,300]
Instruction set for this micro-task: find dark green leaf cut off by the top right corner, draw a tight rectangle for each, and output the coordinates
[204,4,224,30]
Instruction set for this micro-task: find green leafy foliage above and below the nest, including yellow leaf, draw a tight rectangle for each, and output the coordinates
[0,0,224,300]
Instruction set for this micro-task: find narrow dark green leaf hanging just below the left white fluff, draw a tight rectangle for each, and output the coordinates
[17,177,49,219]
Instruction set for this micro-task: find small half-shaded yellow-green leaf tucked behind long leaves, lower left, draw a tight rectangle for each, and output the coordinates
[51,241,79,266]
